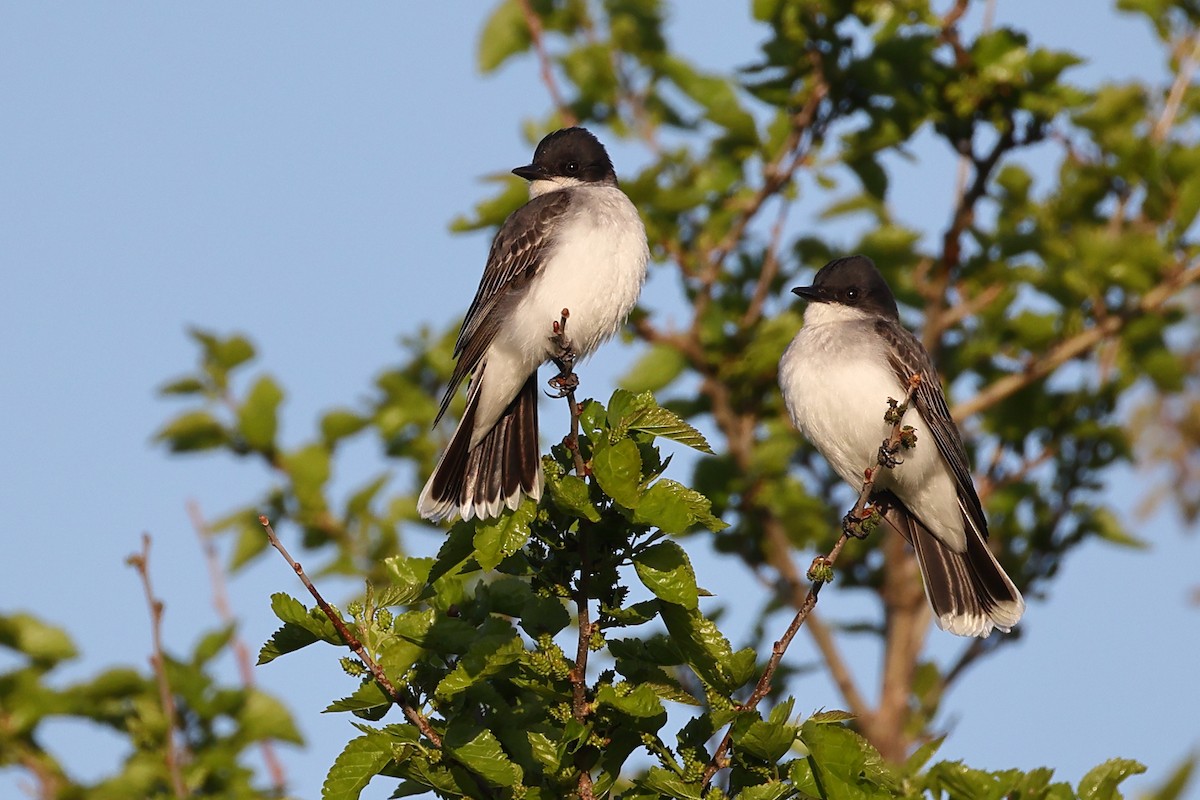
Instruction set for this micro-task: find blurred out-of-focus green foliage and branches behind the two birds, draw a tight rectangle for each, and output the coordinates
[0,0,1200,798]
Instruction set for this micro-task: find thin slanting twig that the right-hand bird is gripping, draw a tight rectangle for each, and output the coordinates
[703,375,920,787]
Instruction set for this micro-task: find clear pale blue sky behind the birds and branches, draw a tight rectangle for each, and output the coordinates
[0,0,1200,798]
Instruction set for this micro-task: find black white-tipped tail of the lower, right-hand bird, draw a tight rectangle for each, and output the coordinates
[884,500,1025,637]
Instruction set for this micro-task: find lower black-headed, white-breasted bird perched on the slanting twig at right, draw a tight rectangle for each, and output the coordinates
[779,255,1025,637]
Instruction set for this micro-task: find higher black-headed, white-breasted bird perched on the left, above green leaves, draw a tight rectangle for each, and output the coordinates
[416,127,650,522]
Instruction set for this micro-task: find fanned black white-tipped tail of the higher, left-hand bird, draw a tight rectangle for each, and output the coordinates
[416,372,542,521]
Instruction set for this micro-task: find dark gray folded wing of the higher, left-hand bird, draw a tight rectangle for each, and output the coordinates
[434,192,571,425]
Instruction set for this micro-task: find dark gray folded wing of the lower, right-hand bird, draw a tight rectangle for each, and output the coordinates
[875,319,988,539]
